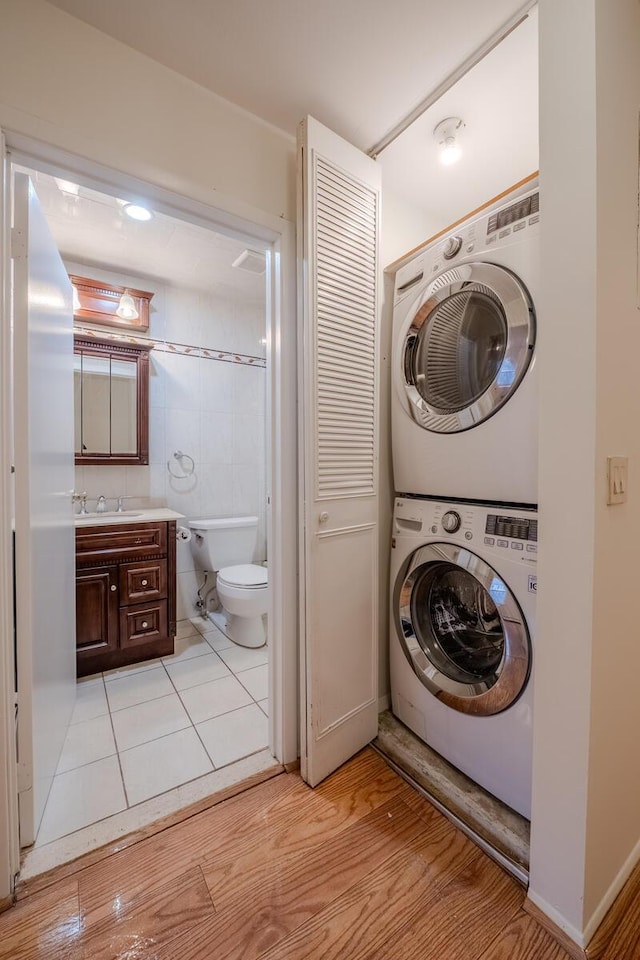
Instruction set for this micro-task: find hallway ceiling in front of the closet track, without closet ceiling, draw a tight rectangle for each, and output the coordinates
[47,0,523,150]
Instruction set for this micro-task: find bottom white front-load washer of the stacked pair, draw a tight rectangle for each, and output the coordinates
[390,498,538,819]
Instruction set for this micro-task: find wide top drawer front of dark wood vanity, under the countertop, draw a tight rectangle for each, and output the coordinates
[76,522,167,564]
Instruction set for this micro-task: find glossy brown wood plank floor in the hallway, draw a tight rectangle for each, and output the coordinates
[0,750,604,960]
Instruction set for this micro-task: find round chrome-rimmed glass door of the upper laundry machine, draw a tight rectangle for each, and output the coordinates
[403,263,535,433]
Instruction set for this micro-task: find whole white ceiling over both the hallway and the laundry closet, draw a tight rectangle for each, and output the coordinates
[45,0,538,229]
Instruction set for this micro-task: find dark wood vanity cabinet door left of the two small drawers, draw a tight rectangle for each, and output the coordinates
[76,565,118,673]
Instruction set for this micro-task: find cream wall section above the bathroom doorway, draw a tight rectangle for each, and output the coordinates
[0,0,295,220]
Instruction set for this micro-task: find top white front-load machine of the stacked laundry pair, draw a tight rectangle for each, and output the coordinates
[392,185,539,505]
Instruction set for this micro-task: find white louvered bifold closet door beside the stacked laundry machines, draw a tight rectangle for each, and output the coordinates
[298,118,380,785]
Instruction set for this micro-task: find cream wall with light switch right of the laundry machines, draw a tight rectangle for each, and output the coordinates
[529,0,640,943]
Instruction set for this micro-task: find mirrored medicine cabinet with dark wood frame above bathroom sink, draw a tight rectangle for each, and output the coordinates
[74,337,151,465]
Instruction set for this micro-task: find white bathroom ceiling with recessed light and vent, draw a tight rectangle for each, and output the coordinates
[19,170,265,302]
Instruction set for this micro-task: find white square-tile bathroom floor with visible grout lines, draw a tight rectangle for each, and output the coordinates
[36,620,268,846]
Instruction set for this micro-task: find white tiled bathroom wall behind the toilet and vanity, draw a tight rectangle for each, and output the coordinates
[66,262,266,617]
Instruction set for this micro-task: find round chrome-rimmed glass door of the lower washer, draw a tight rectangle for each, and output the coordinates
[394,543,531,716]
